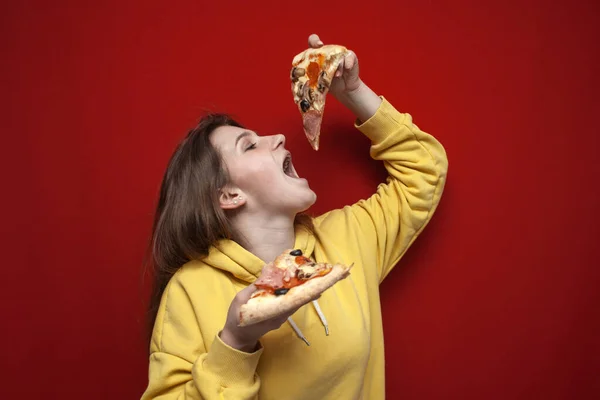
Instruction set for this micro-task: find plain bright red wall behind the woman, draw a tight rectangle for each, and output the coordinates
[0,0,600,399]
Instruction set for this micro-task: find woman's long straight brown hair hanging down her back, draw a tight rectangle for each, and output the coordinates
[148,113,314,337]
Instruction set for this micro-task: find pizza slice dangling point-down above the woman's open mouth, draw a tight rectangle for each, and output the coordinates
[290,44,348,150]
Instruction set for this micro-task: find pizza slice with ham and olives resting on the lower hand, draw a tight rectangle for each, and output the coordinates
[240,250,352,326]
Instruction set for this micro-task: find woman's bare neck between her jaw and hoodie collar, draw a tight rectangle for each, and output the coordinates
[232,209,296,263]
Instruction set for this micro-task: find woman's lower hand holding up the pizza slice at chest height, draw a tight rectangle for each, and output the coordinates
[220,284,318,353]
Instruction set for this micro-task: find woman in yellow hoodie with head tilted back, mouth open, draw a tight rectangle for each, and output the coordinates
[142,35,447,400]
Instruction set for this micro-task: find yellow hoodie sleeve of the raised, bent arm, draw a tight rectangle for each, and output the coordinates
[317,97,448,282]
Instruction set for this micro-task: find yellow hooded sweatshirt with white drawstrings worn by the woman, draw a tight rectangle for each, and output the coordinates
[142,97,448,400]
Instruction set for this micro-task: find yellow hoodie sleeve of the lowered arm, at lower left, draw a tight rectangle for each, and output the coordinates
[142,277,263,400]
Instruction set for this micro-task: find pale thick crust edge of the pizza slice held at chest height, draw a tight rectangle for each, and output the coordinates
[239,264,352,326]
